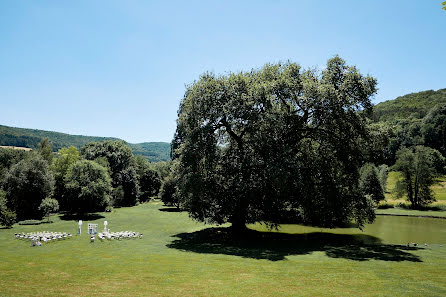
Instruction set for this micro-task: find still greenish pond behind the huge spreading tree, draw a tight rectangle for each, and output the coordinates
[250,215,446,246]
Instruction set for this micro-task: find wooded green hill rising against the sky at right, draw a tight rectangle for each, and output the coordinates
[373,89,446,121]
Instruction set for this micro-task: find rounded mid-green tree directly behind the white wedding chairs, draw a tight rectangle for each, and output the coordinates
[65,160,112,213]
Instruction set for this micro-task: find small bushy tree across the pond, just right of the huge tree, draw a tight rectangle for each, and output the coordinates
[359,163,384,203]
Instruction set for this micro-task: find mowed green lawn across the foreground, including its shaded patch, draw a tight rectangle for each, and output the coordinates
[0,202,446,296]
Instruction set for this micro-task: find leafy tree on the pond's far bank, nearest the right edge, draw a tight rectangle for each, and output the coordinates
[393,146,445,208]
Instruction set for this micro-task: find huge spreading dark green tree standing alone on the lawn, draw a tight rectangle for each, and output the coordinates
[173,57,376,231]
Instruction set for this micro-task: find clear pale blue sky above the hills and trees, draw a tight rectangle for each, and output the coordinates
[0,0,446,142]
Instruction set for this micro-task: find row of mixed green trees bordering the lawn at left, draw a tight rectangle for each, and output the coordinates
[0,138,168,226]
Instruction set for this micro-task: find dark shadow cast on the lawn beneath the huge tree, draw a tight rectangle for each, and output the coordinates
[167,228,422,262]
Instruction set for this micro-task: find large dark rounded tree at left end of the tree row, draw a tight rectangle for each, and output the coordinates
[3,154,54,220]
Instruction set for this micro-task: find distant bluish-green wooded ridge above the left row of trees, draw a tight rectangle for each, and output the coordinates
[0,125,170,162]
